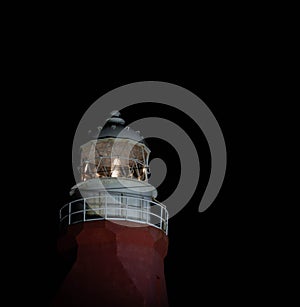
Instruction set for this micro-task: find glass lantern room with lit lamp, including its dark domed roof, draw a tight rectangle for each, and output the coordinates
[80,111,150,181]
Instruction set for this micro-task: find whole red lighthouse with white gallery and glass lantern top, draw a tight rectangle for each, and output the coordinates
[53,111,168,307]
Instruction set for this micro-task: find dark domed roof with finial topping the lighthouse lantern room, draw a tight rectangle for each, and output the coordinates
[98,111,145,144]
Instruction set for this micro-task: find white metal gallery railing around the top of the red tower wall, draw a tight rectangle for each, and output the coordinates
[59,193,169,234]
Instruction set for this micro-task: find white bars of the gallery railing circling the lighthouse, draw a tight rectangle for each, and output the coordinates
[59,193,169,234]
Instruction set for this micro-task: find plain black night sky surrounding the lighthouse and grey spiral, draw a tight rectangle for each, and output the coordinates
[6,3,299,306]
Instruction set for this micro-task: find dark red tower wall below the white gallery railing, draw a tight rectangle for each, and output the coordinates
[54,221,168,307]
